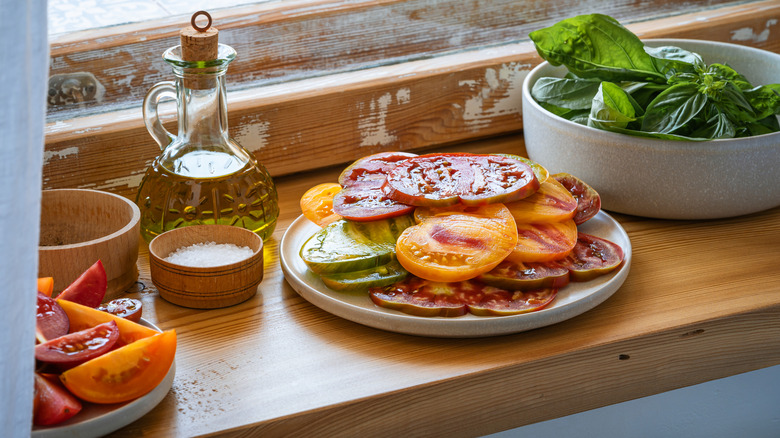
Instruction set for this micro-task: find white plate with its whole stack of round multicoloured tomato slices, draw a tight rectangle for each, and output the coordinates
[280,153,632,338]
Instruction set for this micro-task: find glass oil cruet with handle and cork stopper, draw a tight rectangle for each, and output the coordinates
[136,11,279,242]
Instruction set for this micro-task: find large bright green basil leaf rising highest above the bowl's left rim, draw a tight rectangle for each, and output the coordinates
[529,14,666,83]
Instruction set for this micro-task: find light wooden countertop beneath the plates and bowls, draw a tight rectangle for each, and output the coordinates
[114,136,780,437]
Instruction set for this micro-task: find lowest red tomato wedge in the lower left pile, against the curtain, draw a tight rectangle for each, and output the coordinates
[33,373,82,426]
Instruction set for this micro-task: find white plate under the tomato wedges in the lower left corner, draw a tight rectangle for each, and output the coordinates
[31,318,176,438]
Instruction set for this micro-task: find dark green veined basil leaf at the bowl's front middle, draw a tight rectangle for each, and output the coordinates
[642,83,707,134]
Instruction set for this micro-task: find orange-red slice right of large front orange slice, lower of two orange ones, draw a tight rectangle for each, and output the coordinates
[506,219,577,263]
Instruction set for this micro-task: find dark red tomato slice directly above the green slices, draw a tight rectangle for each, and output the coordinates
[333,184,414,221]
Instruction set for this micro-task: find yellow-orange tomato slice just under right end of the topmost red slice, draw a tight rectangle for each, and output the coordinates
[506,178,577,223]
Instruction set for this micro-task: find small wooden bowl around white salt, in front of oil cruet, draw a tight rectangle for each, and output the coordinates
[149,225,263,309]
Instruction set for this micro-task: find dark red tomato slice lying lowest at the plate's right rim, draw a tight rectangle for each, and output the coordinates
[558,233,624,281]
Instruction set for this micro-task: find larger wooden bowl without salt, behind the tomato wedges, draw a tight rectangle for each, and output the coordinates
[38,189,141,299]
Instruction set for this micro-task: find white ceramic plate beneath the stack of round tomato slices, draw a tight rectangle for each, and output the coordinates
[279,212,631,338]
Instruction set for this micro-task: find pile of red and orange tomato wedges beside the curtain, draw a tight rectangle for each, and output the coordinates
[33,261,176,426]
